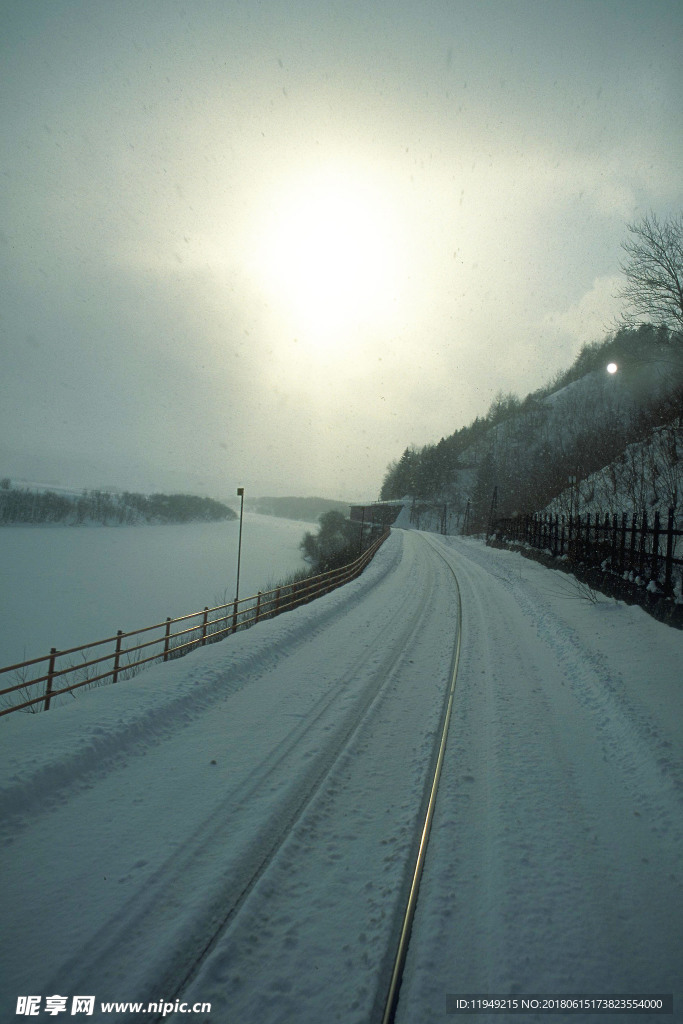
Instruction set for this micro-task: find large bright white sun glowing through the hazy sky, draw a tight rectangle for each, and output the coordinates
[249,172,399,344]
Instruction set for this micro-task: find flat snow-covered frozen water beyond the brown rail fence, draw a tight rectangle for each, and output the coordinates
[0,512,315,666]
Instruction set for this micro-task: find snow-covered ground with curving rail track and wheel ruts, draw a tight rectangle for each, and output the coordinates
[0,530,683,1024]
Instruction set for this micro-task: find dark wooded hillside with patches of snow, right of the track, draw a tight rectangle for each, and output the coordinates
[382,330,683,530]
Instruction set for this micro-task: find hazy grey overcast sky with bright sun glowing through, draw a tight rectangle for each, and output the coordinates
[0,0,683,500]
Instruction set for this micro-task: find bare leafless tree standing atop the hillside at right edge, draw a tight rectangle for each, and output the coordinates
[620,213,683,332]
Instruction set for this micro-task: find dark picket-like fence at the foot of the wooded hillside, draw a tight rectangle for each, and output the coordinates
[490,508,683,597]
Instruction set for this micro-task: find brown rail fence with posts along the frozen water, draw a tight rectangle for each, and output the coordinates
[0,529,389,717]
